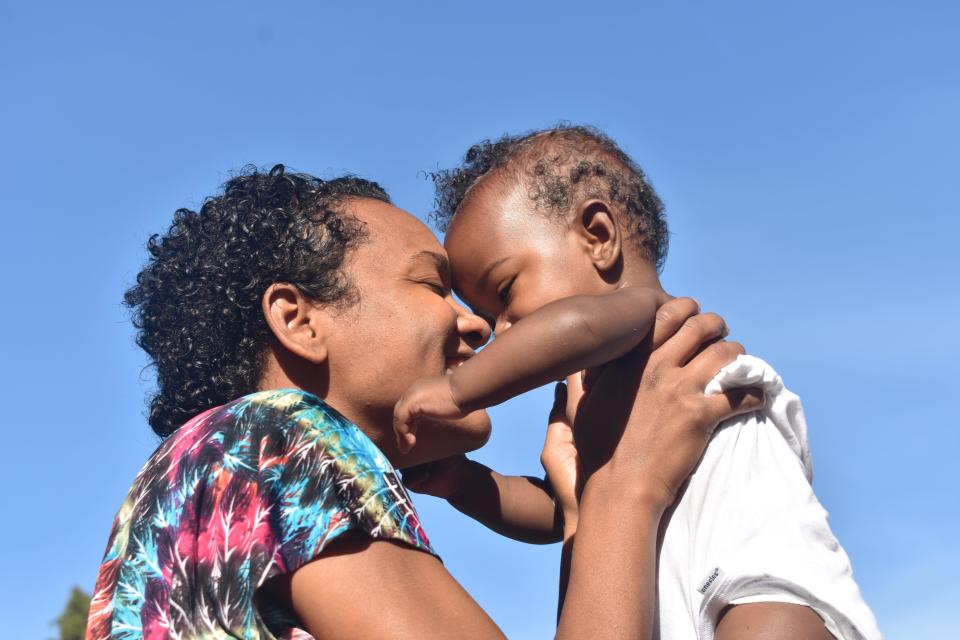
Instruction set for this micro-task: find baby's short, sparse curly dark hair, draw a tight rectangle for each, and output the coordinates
[430,125,669,270]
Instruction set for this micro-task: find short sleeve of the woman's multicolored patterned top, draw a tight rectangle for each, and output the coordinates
[248,391,435,574]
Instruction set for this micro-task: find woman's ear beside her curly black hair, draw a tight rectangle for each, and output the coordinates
[262,282,327,364]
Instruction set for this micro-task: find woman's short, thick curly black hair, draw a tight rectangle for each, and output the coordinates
[124,164,390,437]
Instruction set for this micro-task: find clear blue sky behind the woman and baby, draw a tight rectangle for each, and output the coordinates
[0,1,960,639]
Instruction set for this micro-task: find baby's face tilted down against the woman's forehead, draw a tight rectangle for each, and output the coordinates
[444,178,604,334]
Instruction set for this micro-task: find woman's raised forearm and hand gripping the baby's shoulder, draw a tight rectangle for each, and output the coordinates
[559,302,762,638]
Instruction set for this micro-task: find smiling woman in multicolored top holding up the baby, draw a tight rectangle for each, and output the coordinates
[88,166,759,639]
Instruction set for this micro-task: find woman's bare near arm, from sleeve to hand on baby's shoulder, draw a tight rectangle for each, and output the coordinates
[289,300,759,639]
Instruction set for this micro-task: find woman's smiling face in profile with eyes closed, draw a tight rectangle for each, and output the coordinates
[326,200,490,467]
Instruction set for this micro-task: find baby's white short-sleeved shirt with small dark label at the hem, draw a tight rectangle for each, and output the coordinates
[656,356,882,640]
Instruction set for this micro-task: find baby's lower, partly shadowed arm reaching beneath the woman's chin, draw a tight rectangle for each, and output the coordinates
[403,456,563,544]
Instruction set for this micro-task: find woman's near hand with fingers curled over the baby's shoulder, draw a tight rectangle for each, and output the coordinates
[574,298,763,508]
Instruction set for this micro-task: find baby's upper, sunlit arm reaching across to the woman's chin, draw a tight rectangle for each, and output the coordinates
[395,287,666,452]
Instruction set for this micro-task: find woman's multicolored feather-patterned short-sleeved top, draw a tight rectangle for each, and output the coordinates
[87,389,433,640]
